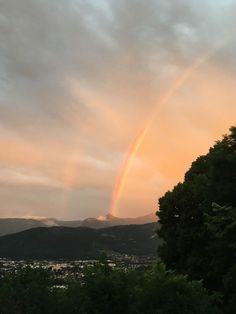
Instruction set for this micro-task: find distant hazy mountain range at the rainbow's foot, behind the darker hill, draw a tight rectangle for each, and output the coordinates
[0,213,157,236]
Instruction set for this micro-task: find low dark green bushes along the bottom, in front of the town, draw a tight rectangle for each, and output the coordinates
[0,260,220,314]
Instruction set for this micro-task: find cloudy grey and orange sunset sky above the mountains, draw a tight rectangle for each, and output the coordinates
[0,0,236,220]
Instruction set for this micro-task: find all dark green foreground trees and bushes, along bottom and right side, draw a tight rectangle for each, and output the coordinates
[0,127,236,314]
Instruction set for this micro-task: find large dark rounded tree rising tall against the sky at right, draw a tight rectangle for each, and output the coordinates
[158,127,236,313]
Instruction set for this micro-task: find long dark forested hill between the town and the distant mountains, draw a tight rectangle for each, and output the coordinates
[0,223,158,259]
